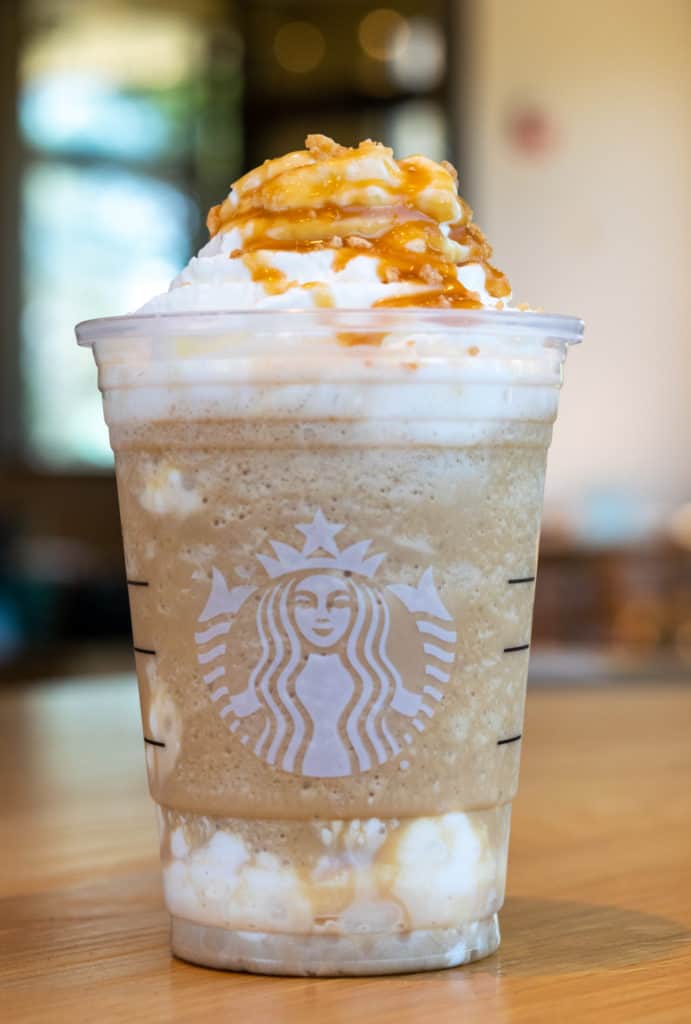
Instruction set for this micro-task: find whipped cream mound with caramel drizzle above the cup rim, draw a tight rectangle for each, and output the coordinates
[139,135,510,313]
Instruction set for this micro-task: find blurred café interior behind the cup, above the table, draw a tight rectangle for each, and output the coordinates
[0,0,691,680]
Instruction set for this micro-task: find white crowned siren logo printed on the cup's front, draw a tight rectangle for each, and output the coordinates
[195,510,457,778]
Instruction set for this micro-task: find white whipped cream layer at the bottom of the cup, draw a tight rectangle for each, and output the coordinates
[159,805,511,935]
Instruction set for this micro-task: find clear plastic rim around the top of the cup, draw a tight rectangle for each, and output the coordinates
[75,306,585,346]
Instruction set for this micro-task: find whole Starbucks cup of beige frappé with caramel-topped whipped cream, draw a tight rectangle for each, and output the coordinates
[78,137,581,974]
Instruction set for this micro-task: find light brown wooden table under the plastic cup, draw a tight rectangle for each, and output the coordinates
[0,677,691,1024]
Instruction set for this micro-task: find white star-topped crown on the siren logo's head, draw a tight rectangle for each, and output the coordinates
[257,509,386,580]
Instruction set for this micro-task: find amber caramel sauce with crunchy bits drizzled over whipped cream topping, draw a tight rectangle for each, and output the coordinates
[207,135,511,309]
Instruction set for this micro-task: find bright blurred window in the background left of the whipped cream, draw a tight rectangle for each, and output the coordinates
[18,0,242,468]
